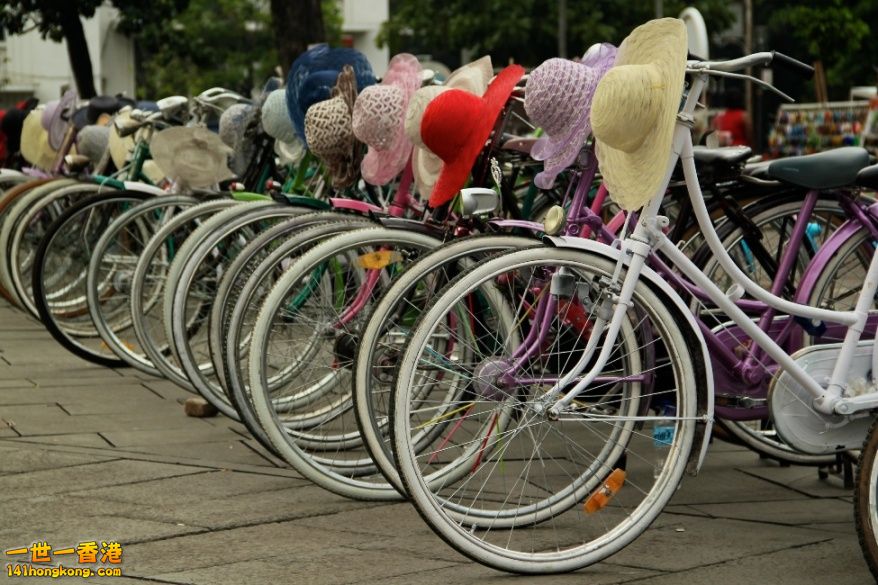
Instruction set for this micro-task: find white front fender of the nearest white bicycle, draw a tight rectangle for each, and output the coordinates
[543,236,714,475]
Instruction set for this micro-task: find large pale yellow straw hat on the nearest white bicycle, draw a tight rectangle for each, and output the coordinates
[591,18,687,211]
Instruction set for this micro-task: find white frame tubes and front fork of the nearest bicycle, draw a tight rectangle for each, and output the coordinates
[545,72,878,415]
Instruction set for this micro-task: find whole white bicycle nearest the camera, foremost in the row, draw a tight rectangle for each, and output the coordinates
[391,19,878,573]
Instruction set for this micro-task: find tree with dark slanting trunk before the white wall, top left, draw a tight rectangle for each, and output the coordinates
[0,0,187,98]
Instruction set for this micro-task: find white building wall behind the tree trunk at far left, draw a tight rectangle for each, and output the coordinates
[0,6,134,101]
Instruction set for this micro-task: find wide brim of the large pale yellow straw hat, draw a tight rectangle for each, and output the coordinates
[592,18,687,211]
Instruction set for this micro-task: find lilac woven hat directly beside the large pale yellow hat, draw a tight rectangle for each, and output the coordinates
[524,43,616,189]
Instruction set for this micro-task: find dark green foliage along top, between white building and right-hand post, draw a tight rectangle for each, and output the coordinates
[379,0,733,65]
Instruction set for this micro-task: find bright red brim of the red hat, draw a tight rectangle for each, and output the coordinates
[427,65,524,207]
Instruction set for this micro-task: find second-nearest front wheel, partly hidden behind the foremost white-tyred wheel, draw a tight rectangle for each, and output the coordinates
[353,235,535,493]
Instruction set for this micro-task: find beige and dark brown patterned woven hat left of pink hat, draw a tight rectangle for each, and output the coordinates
[305,65,362,189]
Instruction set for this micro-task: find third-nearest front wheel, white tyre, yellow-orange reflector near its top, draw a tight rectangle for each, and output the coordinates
[248,228,450,500]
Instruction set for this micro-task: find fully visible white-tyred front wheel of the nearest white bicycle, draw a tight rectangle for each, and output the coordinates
[391,247,707,573]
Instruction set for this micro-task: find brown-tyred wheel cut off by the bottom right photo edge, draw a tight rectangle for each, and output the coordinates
[854,421,878,581]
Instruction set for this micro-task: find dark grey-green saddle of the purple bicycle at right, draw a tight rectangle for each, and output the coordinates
[766,146,869,189]
